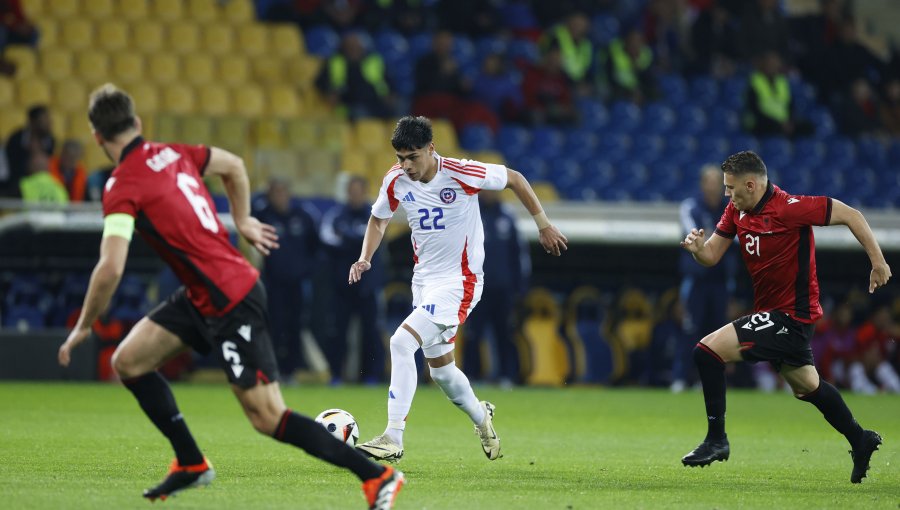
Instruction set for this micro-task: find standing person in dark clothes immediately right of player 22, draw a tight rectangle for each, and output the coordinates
[463,190,531,386]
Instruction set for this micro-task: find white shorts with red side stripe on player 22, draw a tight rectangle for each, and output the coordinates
[407,280,484,358]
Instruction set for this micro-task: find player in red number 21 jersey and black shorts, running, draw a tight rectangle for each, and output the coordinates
[681,151,891,483]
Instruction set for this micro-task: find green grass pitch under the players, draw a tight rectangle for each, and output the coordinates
[0,382,900,510]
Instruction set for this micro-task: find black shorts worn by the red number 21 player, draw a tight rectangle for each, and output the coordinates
[732,312,815,371]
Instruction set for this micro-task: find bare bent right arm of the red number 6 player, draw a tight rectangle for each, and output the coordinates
[206,147,278,255]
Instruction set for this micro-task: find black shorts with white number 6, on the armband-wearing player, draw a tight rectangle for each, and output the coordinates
[147,281,278,389]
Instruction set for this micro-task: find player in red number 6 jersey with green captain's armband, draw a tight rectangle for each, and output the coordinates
[59,84,403,508]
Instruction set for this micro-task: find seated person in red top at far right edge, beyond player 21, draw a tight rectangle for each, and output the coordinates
[850,301,900,394]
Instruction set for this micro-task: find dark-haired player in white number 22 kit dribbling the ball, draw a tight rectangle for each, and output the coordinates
[349,117,568,461]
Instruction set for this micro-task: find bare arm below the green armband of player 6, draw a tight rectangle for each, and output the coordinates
[57,235,130,367]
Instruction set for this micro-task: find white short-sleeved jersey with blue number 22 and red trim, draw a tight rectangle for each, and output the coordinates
[372,153,507,285]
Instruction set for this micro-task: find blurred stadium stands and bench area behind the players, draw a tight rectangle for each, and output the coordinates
[0,0,900,393]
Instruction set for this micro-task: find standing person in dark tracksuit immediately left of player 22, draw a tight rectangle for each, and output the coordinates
[321,176,385,384]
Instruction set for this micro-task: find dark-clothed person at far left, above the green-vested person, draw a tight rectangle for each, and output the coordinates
[0,105,56,196]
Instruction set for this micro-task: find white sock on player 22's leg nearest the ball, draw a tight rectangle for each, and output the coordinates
[384,327,419,446]
